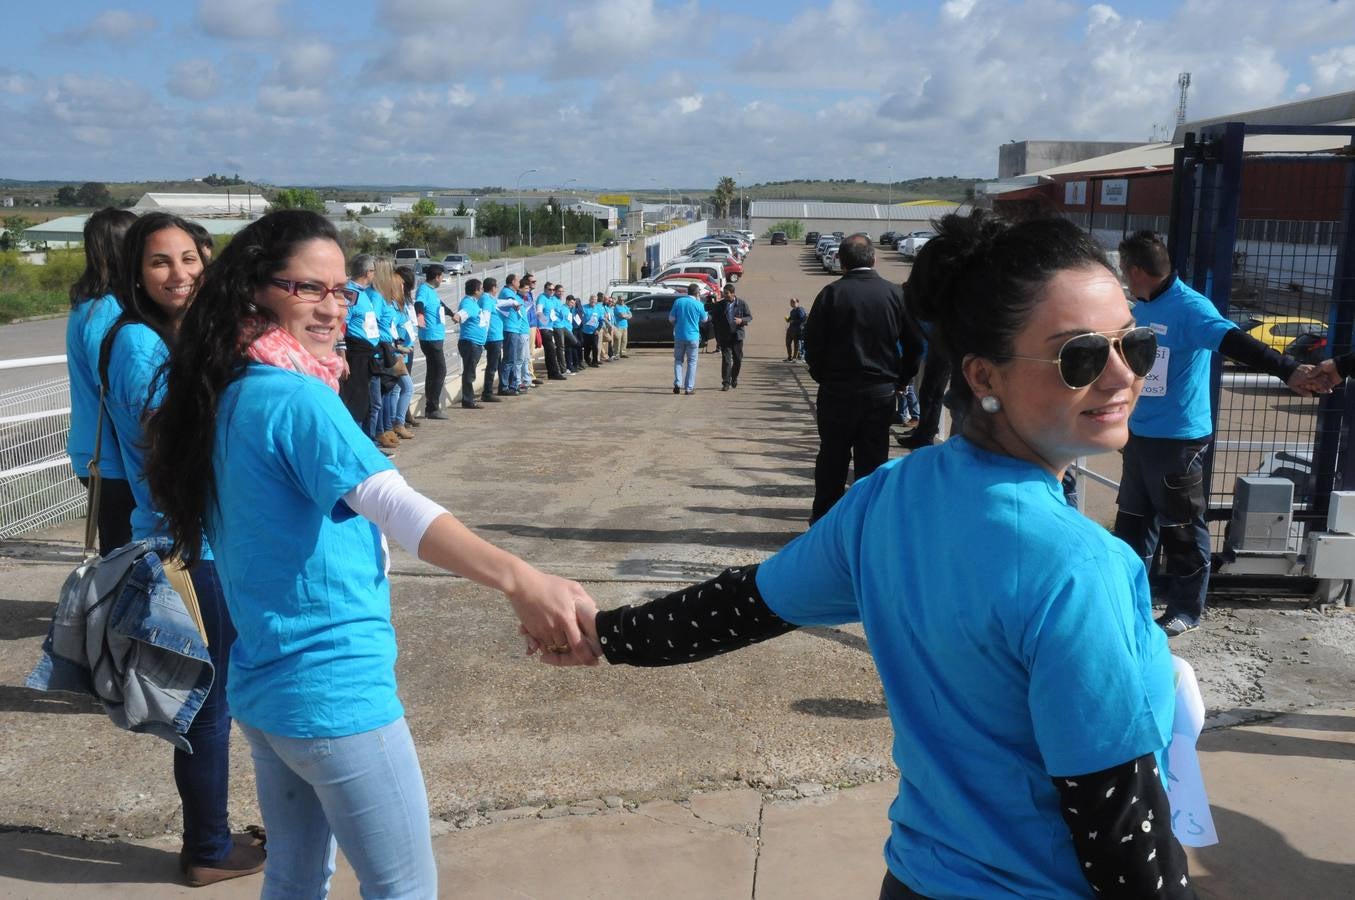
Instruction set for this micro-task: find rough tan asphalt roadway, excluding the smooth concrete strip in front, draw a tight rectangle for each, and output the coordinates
[0,243,1355,836]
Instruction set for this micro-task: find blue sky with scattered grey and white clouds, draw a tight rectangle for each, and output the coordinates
[0,0,1355,188]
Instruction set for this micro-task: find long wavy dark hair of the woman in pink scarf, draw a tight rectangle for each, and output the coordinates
[146,210,339,563]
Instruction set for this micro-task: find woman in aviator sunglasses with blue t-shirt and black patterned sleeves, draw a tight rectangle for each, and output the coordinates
[555,213,1194,897]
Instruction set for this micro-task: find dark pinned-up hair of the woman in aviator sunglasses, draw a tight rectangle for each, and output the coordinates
[906,210,1114,413]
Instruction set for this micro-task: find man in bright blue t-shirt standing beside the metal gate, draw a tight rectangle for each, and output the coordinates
[1115,232,1312,637]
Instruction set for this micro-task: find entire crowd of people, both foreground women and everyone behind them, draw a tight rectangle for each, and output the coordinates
[55,210,1333,899]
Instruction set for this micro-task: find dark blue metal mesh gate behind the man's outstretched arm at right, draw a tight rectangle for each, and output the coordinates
[1168,122,1355,590]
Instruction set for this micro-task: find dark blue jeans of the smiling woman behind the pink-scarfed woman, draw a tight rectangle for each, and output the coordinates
[173,560,236,865]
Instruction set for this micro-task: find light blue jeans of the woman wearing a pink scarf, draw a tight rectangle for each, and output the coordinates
[241,718,438,900]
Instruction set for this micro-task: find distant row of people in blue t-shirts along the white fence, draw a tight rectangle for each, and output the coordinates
[339,260,631,441]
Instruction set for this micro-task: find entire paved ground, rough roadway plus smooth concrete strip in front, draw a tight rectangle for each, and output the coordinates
[0,238,1355,897]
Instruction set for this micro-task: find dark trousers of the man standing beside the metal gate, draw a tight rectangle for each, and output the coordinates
[1115,434,1210,622]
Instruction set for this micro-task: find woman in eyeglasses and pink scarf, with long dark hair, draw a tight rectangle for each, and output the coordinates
[146,210,595,897]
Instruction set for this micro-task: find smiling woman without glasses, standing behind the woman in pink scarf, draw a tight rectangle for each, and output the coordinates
[95,213,264,886]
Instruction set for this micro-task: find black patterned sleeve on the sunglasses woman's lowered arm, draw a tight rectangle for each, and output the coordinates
[1053,754,1195,900]
